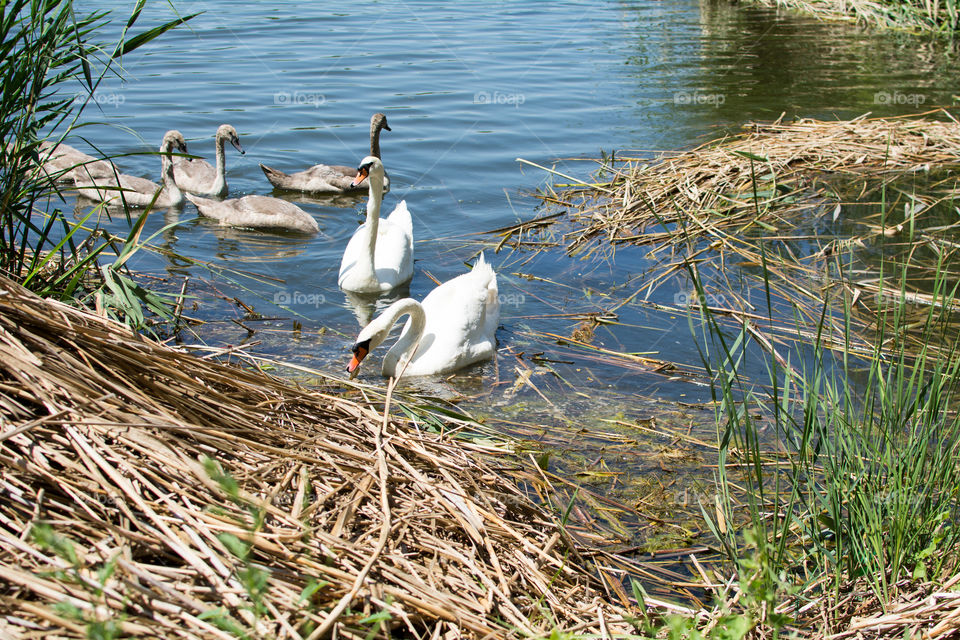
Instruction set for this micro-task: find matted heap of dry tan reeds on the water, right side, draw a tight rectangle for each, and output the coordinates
[565,111,960,252]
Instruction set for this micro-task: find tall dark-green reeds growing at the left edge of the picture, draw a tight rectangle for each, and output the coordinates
[0,0,194,325]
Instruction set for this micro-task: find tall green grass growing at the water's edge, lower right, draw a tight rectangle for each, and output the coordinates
[698,205,960,610]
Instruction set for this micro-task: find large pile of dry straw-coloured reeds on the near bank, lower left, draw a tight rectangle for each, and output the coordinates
[0,279,644,639]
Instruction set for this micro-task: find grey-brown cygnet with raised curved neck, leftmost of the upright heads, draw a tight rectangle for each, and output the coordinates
[76,130,187,207]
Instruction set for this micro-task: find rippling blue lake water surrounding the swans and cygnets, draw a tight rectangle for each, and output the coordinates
[60,0,960,520]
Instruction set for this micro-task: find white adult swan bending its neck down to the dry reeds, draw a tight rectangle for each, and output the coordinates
[347,253,500,378]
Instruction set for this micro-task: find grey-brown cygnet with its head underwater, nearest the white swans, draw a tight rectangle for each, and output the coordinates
[187,193,320,238]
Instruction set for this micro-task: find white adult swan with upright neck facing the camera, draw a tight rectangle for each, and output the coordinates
[337,156,413,293]
